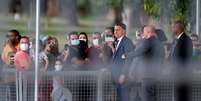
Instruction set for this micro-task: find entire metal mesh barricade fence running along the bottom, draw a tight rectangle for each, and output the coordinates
[0,70,201,101]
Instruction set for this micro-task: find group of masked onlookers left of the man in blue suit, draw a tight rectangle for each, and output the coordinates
[1,27,115,71]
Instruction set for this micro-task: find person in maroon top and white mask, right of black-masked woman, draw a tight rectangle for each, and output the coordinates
[88,32,103,68]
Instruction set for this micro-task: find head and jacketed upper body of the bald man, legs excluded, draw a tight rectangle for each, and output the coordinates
[126,25,163,61]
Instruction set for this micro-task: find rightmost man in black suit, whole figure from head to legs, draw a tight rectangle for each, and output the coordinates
[170,21,193,101]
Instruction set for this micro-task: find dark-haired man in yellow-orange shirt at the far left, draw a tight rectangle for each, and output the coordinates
[1,29,21,67]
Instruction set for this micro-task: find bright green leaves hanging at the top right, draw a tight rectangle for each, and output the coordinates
[144,0,190,23]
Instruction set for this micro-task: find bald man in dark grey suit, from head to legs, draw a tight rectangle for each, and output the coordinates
[126,25,164,101]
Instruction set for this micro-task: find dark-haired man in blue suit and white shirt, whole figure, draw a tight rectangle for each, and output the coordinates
[112,23,135,101]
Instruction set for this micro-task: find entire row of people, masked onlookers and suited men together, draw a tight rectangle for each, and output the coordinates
[1,21,201,101]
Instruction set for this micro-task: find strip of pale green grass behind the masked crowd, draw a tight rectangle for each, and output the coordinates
[0,15,140,51]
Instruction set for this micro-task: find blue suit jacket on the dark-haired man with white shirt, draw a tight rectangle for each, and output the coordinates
[112,36,135,80]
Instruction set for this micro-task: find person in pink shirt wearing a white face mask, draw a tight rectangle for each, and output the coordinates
[14,36,32,71]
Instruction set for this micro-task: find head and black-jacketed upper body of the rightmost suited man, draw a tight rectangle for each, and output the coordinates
[170,21,193,67]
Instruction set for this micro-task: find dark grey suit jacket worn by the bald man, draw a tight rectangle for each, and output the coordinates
[126,37,165,79]
